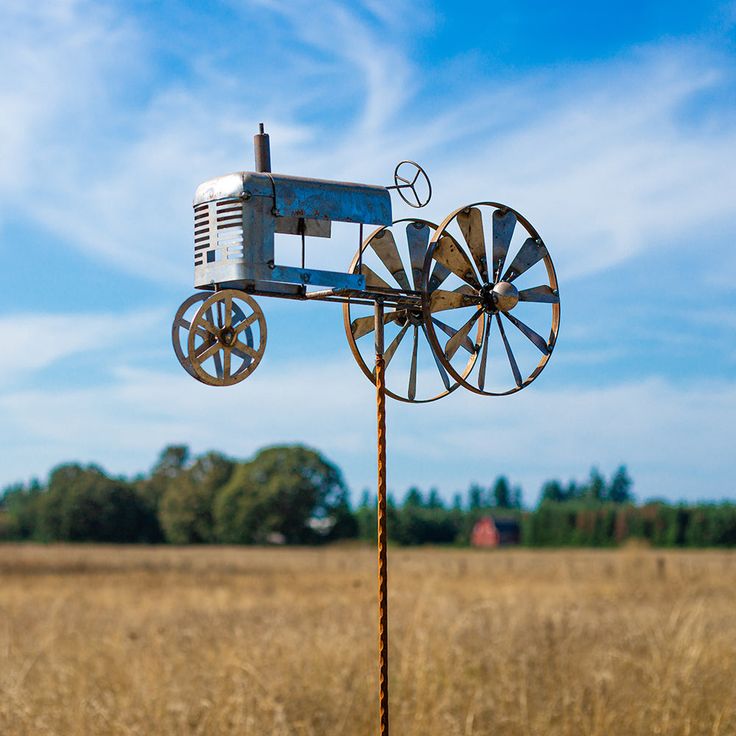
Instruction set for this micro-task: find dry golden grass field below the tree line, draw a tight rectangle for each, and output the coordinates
[0,545,736,736]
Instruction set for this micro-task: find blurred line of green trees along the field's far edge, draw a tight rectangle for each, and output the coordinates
[0,445,736,547]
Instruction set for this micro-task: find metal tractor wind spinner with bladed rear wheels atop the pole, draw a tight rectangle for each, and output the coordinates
[172,125,560,402]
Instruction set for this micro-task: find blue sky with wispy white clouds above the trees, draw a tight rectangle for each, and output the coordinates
[0,0,736,503]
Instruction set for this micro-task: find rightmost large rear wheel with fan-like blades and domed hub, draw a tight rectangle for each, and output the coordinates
[422,202,560,396]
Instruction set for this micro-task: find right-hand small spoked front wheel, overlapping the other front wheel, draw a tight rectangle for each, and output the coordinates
[187,289,266,386]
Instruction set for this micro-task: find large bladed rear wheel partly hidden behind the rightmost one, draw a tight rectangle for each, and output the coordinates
[343,219,480,403]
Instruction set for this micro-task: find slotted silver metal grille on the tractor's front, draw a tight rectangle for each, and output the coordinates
[194,199,243,266]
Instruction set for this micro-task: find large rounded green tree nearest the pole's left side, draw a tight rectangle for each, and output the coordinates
[215,445,356,544]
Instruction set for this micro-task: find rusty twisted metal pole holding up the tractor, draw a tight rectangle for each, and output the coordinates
[375,301,388,736]
